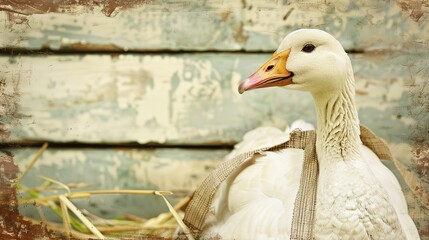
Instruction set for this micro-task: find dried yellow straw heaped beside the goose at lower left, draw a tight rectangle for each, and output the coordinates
[14,143,194,240]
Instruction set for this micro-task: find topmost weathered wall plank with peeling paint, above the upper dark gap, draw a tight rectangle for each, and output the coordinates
[0,0,429,51]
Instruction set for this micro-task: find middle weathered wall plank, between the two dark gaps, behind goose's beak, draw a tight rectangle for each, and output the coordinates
[0,53,429,144]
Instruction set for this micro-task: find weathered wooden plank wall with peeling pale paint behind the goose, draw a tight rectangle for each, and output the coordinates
[0,0,429,239]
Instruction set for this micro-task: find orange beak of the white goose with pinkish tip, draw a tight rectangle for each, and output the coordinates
[238,49,293,94]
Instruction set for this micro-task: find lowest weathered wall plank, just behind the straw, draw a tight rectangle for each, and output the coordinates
[12,148,228,218]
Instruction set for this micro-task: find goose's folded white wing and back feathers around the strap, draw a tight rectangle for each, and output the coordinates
[203,120,313,239]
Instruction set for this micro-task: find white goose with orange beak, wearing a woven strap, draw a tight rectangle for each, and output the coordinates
[202,29,419,239]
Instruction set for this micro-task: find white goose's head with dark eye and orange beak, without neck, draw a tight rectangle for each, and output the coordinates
[238,29,352,94]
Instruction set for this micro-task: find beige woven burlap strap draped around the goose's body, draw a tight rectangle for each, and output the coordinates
[184,126,393,239]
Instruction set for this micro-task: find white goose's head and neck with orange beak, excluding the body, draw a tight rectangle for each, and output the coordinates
[238,29,360,161]
